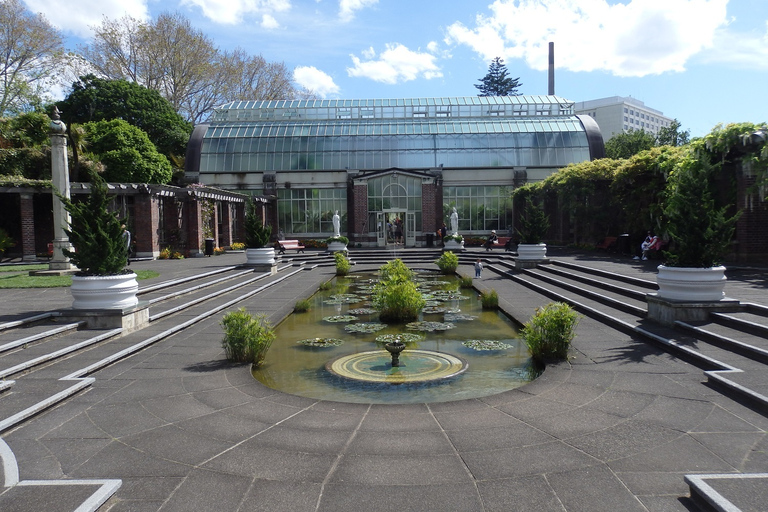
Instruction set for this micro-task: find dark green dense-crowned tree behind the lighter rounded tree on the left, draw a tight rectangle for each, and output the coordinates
[58,75,192,156]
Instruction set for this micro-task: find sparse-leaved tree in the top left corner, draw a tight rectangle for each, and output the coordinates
[0,0,64,116]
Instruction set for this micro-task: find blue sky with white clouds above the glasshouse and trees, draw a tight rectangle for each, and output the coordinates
[24,0,768,137]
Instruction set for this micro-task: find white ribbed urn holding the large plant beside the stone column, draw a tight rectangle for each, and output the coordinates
[70,272,139,309]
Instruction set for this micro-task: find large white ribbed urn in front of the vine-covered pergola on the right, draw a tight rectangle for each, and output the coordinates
[656,265,726,302]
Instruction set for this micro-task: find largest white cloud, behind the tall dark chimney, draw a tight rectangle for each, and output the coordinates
[445,0,728,76]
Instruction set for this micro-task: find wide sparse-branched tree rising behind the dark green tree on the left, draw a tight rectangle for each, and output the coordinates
[80,13,298,123]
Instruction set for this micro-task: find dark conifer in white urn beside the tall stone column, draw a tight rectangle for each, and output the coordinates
[58,171,139,309]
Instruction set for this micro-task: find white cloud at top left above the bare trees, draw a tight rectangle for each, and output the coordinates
[24,0,149,39]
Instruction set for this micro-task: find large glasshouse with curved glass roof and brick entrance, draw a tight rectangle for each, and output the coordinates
[186,96,605,247]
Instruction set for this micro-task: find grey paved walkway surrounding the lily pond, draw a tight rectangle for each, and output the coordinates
[0,253,768,512]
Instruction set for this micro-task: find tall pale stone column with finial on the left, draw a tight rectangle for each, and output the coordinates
[48,108,73,270]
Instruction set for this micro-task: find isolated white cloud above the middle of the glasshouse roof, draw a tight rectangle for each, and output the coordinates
[347,43,443,84]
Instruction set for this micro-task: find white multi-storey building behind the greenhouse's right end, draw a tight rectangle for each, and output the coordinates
[574,96,674,142]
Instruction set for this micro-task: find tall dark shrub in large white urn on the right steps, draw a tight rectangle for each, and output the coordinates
[656,151,741,302]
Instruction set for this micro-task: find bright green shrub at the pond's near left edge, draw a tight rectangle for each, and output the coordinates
[221,308,275,366]
